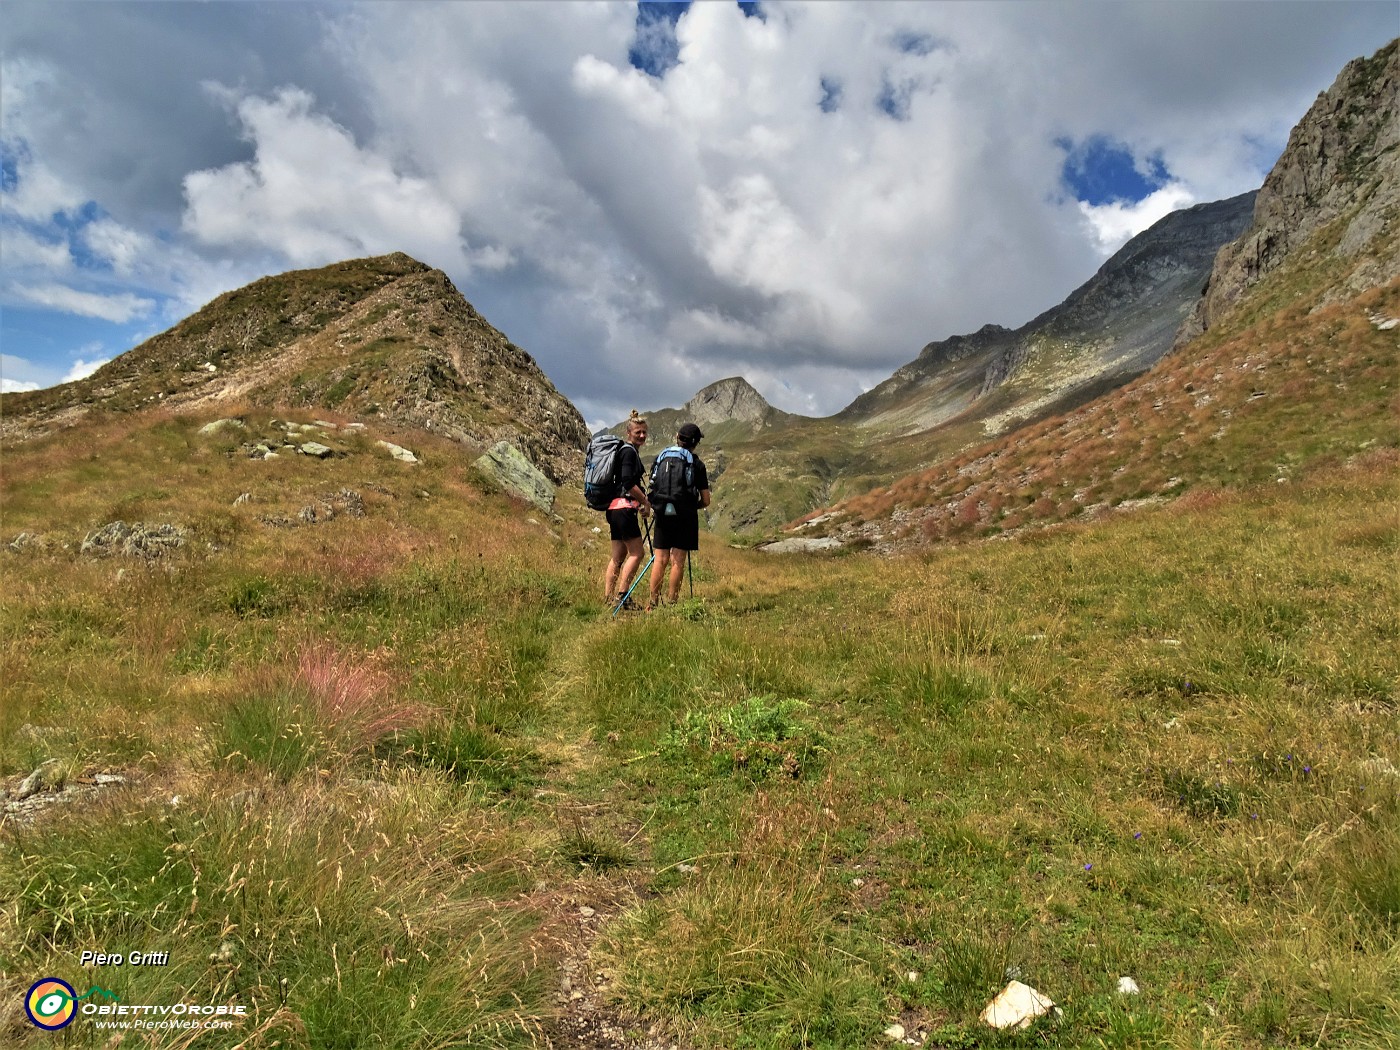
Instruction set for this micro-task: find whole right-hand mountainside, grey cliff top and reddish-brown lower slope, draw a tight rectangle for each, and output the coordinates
[816,43,1400,549]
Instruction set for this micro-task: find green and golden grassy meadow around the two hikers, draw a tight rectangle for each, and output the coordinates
[0,414,1400,1050]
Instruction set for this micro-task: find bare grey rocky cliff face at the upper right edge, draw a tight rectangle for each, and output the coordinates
[1176,41,1400,344]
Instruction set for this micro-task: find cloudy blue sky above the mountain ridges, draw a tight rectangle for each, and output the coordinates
[0,0,1400,426]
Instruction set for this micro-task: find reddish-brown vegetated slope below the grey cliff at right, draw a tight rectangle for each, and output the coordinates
[832,271,1400,549]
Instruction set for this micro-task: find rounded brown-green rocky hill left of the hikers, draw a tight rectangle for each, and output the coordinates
[0,253,588,480]
